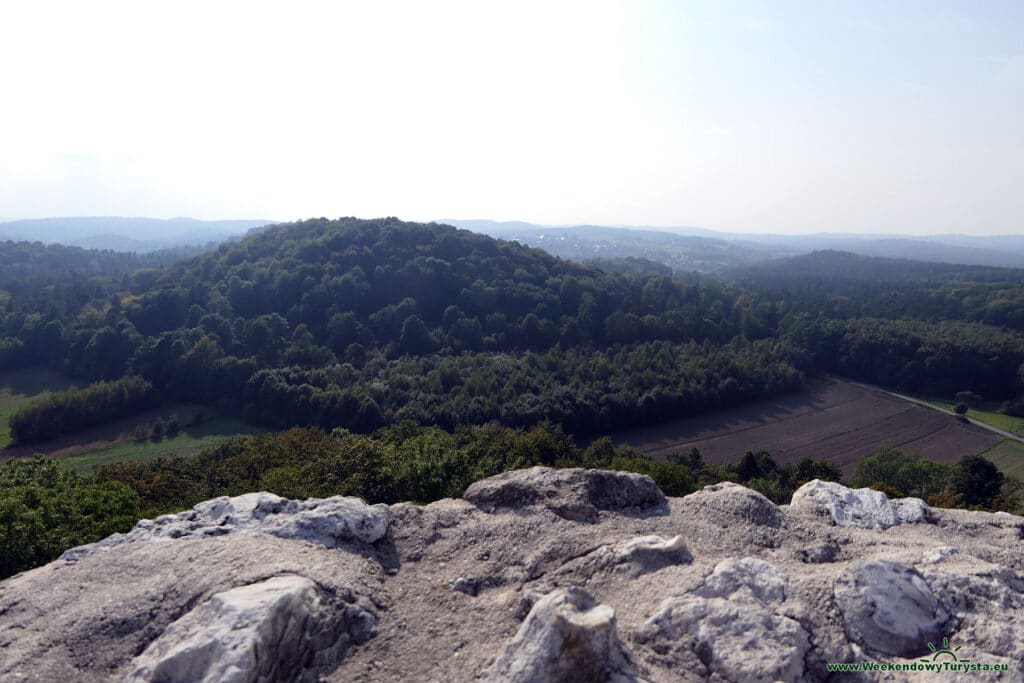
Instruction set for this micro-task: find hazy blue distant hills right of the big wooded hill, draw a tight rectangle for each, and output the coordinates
[438,218,1024,271]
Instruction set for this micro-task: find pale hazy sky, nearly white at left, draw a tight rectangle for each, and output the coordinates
[0,0,1024,234]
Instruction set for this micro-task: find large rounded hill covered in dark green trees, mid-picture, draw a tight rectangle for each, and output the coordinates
[0,218,803,442]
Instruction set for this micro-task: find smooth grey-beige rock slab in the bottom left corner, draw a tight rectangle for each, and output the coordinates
[0,533,388,683]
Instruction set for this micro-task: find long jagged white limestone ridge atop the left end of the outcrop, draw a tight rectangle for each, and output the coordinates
[60,492,388,560]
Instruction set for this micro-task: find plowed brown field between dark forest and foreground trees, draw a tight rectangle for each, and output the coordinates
[611,380,1000,474]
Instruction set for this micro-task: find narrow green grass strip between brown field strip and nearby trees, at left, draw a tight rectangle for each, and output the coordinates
[57,418,264,474]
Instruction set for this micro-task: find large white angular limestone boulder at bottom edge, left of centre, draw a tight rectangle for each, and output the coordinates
[125,575,376,683]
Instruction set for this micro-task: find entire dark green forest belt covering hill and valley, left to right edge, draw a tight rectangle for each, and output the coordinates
[0,218,1024,444]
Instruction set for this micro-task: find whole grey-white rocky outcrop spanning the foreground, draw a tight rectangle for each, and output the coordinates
[0,468,1024,683]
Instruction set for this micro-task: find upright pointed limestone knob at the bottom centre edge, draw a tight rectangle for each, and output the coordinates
[480,587,640,683]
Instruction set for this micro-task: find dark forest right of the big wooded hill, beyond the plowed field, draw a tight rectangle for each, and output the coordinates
[732,252,1024,411]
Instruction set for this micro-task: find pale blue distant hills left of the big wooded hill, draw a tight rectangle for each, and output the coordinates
[0,216,273,253]
